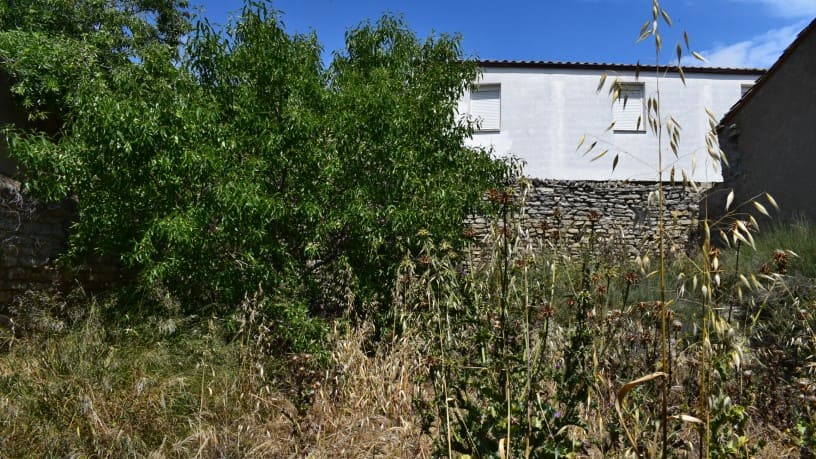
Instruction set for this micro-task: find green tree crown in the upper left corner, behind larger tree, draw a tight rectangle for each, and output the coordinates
[0,0,190,125]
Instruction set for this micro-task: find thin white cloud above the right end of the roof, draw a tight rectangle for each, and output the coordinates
[683,20,816,68]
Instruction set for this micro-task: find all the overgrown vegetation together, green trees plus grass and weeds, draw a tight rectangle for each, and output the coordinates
[0,1,816,458]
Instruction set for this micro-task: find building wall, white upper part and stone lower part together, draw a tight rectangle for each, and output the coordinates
[458,61,762,256]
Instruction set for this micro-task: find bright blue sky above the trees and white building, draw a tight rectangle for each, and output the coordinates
[191,0,816,67]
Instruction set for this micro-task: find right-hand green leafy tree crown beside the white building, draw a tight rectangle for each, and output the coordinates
[322,17,503,312]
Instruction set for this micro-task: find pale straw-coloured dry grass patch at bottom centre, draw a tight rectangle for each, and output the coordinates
[303,326,433,457]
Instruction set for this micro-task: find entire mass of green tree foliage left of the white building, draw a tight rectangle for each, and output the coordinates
[0,0,504,344]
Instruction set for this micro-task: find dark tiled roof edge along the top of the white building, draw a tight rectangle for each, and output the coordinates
[476,60,765,75]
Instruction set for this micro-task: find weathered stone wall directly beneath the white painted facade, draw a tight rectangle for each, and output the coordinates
[468,180,701,257]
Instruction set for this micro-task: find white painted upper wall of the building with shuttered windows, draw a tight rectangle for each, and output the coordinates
[459,61,762,182]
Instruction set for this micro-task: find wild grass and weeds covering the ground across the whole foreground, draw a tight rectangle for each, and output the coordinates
[0,222,816,457]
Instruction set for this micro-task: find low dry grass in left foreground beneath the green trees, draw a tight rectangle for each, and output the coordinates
[0,296,432,458]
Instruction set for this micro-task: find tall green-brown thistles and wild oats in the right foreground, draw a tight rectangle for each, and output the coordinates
[396,192,816,457]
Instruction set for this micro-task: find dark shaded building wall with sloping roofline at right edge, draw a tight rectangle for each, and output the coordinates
[710,21,816,221]
